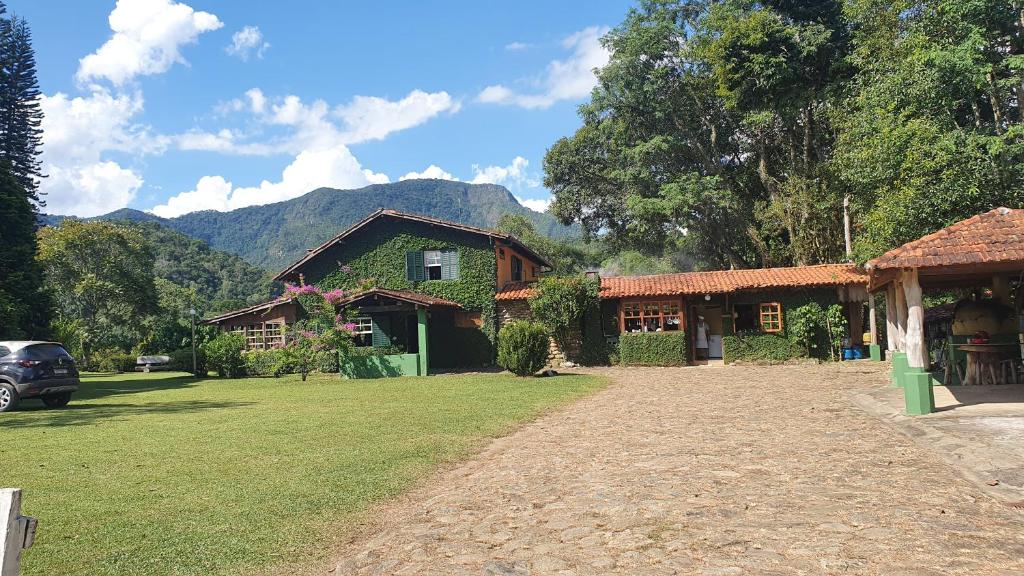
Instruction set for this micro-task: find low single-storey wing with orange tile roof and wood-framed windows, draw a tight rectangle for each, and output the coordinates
[496,264,867,364]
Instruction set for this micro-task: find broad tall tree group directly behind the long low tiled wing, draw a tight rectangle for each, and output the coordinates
[545,0,849,268]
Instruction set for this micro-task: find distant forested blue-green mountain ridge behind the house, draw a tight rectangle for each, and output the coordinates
[41,179,578,271]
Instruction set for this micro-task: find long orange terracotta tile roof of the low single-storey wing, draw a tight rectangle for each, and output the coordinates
[496,264,867,300]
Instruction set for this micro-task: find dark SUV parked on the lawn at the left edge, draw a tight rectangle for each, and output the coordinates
[0,341,79,412]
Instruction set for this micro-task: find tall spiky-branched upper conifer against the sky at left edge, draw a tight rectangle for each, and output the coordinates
[0,9,45,206]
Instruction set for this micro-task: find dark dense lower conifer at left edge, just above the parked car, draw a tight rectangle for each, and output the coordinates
[0,162,50,339]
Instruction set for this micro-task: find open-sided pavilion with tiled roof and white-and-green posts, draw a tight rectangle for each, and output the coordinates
[865,208,1024,415]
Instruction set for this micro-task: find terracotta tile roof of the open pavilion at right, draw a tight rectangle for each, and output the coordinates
[867,204,1024,272]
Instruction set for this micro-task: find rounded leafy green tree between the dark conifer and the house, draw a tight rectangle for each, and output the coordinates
[39,219,158,360]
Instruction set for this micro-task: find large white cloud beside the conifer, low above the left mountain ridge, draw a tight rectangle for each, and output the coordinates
[40,88,168,216]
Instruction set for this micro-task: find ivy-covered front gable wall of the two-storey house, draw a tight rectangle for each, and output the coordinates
[299,217,497,367]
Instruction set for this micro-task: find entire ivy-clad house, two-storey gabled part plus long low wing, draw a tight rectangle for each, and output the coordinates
[207,209,867,374]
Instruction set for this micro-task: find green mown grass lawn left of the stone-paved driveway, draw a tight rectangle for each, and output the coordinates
[0,373,603,576]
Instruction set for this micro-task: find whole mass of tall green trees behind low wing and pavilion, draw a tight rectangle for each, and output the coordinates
[545,0,1024,268]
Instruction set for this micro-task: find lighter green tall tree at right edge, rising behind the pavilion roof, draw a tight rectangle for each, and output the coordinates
[834,0,1024,258]
